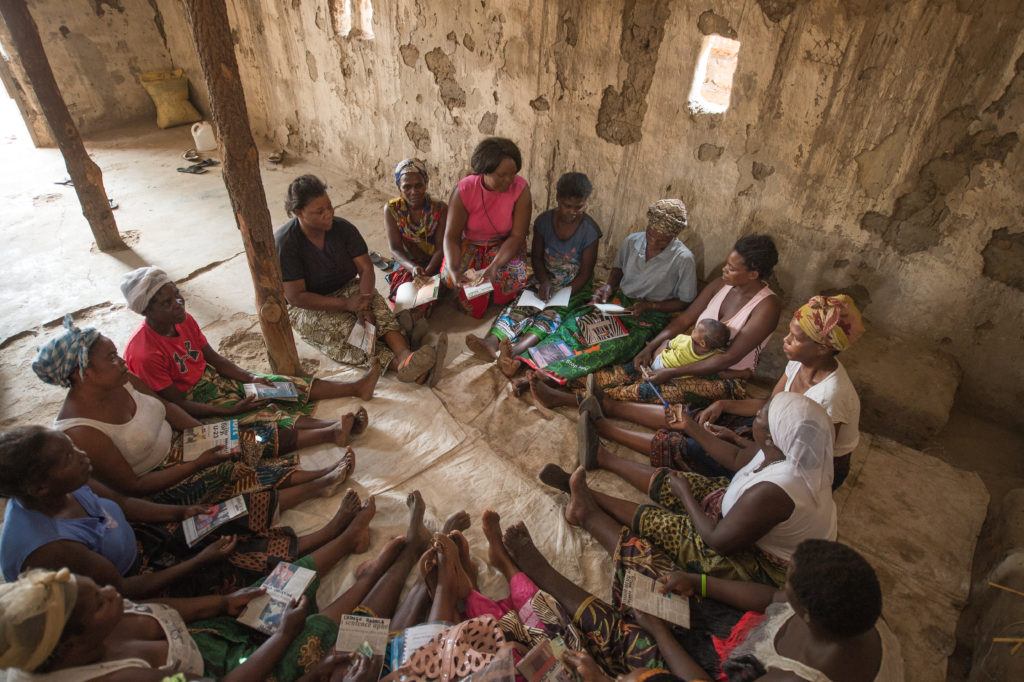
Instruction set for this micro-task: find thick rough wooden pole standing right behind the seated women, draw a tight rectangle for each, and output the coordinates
[183,0,301,375]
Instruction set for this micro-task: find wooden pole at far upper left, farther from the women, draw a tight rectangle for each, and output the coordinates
[0,0,126,251]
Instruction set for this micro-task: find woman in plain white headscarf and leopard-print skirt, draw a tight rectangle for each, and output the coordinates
[541,392,836,586]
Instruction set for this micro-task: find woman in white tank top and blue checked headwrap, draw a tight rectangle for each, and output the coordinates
[32,315,365,505]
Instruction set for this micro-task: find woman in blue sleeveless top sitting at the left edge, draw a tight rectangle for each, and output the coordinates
[0,426,358,597]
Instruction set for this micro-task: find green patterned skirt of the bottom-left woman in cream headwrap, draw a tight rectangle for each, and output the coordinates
[188,556,338,682]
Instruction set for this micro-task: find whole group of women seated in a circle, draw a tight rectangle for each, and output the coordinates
[0,138,902,682]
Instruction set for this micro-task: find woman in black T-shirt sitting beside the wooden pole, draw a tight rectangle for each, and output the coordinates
[274,175,439,382]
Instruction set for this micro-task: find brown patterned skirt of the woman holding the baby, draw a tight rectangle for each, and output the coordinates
[594,361,746,409]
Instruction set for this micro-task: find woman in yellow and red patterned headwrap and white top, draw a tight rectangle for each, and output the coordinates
[592,295,864,489]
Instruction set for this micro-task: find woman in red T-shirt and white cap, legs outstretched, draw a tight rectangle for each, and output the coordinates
[121,267,379,430]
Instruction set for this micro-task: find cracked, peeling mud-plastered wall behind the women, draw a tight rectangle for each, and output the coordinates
[6,0,1024,423]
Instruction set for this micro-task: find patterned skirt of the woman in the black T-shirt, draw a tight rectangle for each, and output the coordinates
[288,280,401,373]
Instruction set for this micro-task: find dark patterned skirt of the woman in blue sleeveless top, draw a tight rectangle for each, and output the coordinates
[132,491,298,597]
